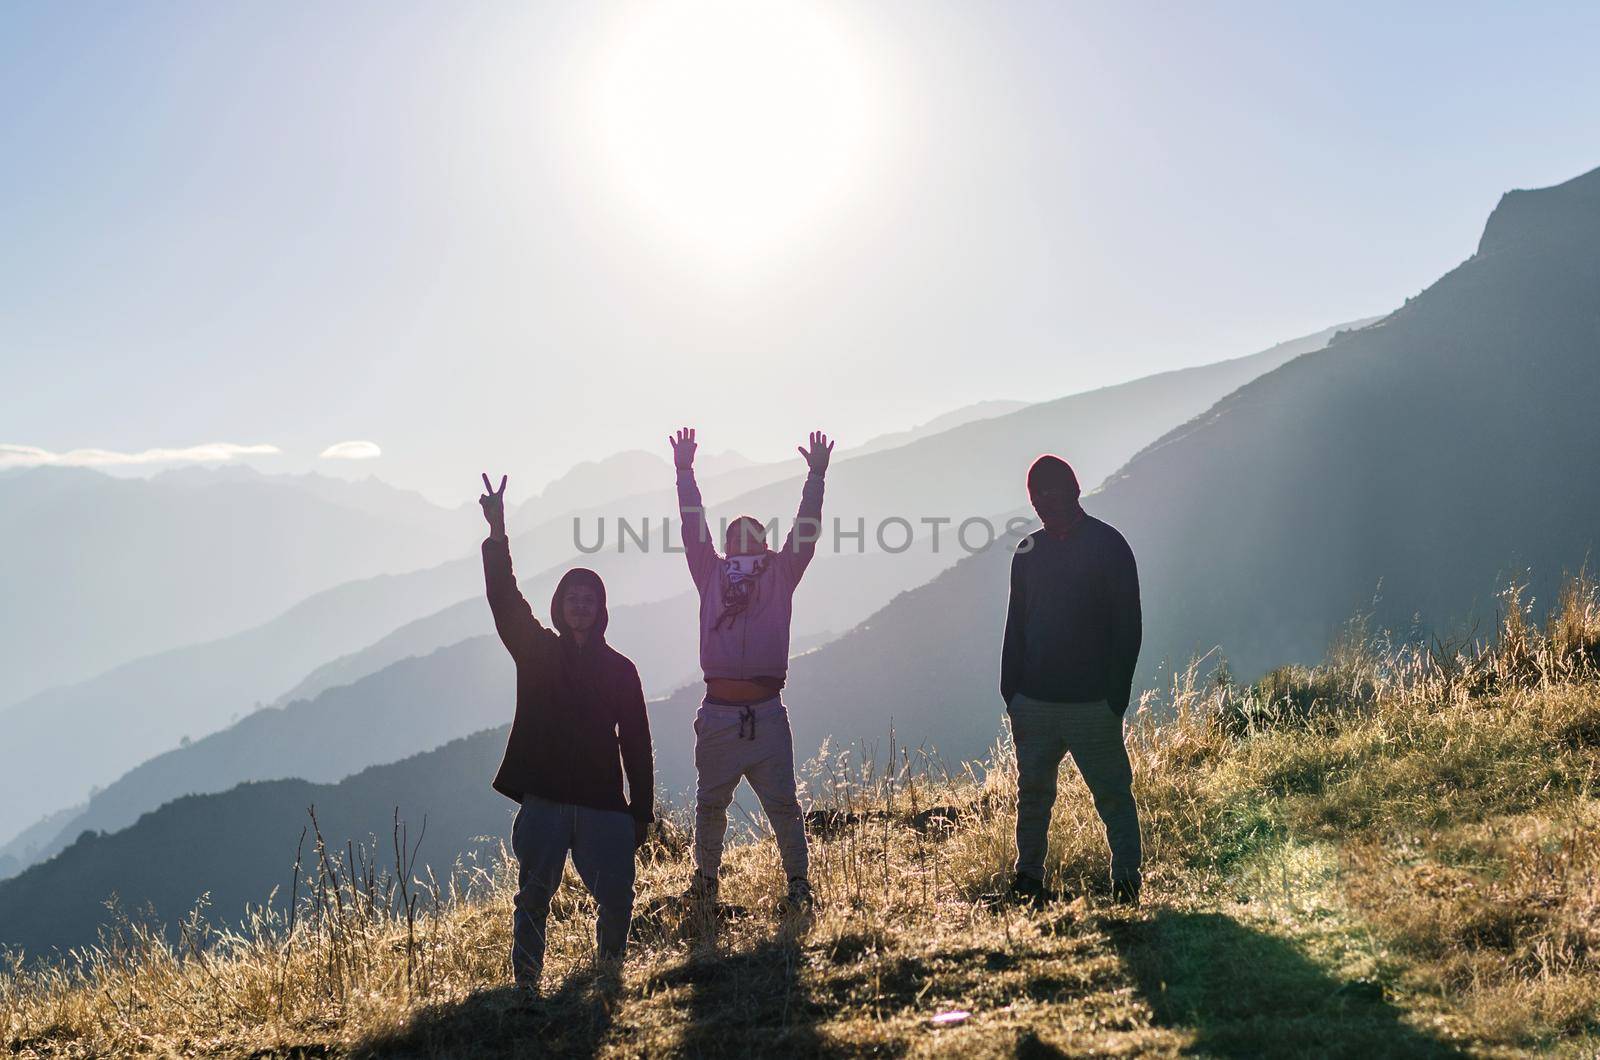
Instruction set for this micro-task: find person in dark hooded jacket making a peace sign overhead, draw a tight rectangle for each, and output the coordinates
[478,474,656,994]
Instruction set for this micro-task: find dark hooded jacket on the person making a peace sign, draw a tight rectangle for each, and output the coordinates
[483,538,656,821]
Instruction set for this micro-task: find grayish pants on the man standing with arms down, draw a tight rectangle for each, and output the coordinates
[1006,693,1144,881]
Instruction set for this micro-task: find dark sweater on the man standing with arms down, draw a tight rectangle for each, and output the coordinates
[1000,516,1142,714]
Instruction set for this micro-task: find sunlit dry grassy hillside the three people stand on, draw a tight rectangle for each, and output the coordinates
[0,588,1600,1058]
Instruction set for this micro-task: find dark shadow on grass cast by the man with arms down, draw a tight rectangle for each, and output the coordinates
[1104,909,1467,1058]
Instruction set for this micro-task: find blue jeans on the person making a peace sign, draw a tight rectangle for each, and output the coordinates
[510,796,634,985]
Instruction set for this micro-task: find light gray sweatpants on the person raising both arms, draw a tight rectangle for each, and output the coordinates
[694,697,810,879]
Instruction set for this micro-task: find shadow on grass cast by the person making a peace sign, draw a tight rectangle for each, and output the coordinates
[350,970,621,1060]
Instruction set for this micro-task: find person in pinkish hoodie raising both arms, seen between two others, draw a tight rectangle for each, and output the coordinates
[667,428,834,914]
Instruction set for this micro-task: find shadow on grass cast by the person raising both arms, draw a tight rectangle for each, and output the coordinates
[656,934,856,1057]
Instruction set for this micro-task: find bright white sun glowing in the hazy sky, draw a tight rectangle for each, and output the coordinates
[595,0,877,267]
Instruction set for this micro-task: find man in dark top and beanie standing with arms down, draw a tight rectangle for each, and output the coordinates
[1000,455,1142,903]
